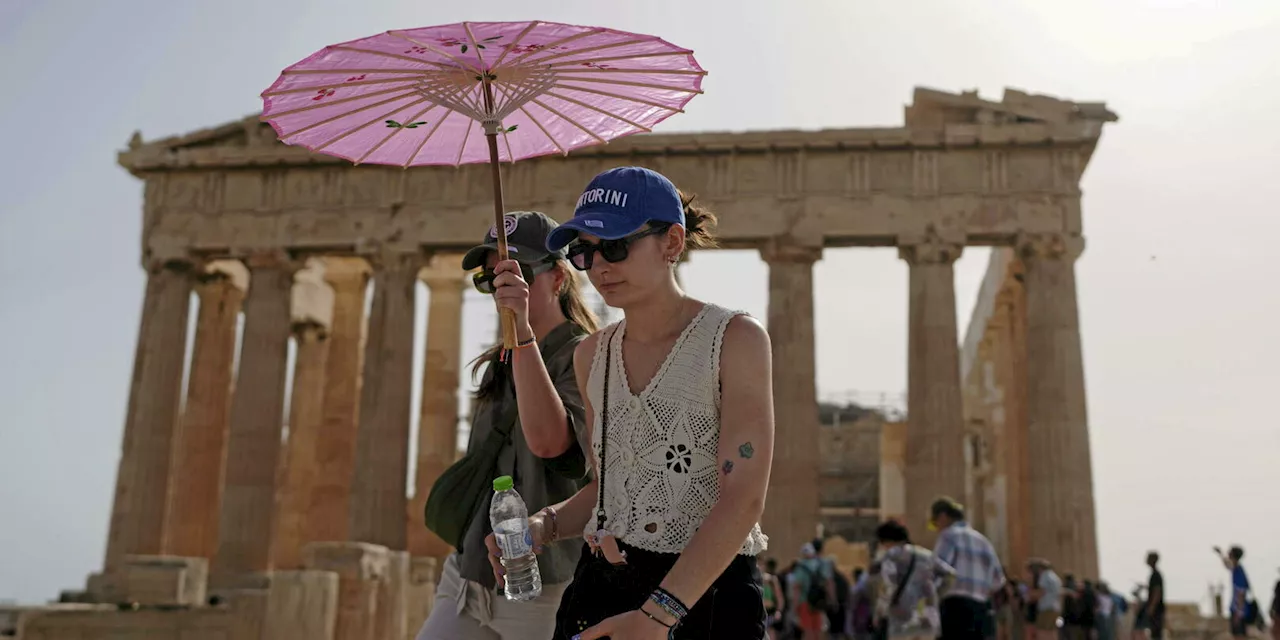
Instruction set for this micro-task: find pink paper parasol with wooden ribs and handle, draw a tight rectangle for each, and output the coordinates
[262,20,707,348]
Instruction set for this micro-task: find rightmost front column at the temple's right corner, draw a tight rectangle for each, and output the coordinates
[1018,234,1098,577]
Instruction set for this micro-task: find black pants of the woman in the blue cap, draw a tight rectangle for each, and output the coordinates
[552,541,765,640]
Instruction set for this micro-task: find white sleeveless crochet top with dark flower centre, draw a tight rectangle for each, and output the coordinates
[584,303,768,556]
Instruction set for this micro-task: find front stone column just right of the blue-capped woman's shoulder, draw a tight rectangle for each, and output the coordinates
[760,241,822,563]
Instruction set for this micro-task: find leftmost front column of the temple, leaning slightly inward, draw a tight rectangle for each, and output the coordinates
[104,260,195,571]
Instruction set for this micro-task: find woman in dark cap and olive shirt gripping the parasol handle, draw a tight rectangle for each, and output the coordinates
[417,211,596,640]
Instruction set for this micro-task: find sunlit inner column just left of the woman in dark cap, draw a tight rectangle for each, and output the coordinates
[408,255,470,558]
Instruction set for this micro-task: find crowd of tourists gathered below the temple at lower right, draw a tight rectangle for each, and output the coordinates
[760,498,1280,640]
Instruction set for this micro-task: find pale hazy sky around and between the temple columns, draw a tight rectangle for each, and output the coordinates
[0,0,1280,609]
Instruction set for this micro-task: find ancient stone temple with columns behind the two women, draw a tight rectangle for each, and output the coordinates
[10,88,1116,640]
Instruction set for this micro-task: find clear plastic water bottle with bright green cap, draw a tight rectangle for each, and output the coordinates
[489,476,543,602]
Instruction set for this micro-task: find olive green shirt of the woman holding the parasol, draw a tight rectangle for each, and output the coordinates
[458,323,589,589]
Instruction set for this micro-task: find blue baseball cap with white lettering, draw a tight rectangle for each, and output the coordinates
[547,166,685,251]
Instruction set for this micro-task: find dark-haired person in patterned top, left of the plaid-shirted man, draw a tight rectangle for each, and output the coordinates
[876,520,956,640]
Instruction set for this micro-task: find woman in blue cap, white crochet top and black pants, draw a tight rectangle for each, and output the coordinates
[483,166,773,640]
